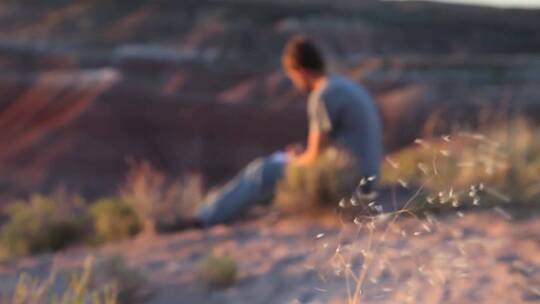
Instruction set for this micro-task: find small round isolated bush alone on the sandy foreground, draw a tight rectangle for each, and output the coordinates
[199,255,238,288]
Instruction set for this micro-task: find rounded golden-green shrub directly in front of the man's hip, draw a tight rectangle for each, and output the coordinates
[274,148,360,213]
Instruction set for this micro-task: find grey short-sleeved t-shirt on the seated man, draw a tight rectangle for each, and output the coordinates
[307,75,383,177]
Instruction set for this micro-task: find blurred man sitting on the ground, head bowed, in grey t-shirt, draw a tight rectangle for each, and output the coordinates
[189,36,383,226]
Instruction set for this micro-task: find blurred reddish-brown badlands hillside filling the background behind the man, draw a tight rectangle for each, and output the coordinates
[0,0,540,195]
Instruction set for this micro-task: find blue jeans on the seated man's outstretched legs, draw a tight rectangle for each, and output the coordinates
[197,152,287,226]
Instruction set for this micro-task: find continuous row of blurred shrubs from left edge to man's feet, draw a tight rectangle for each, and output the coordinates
[0,163,207,258]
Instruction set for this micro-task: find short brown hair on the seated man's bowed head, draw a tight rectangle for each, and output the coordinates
[281,35,326,73]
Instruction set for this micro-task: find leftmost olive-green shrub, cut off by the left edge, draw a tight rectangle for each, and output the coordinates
[0,195,86,256]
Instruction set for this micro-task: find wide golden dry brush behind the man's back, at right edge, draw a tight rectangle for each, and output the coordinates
[382,119,540,213]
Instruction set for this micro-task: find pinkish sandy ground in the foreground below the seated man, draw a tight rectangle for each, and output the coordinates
[0,205,540,304]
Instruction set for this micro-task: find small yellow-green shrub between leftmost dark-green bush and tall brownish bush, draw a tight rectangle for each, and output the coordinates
[90,198,142,242]
